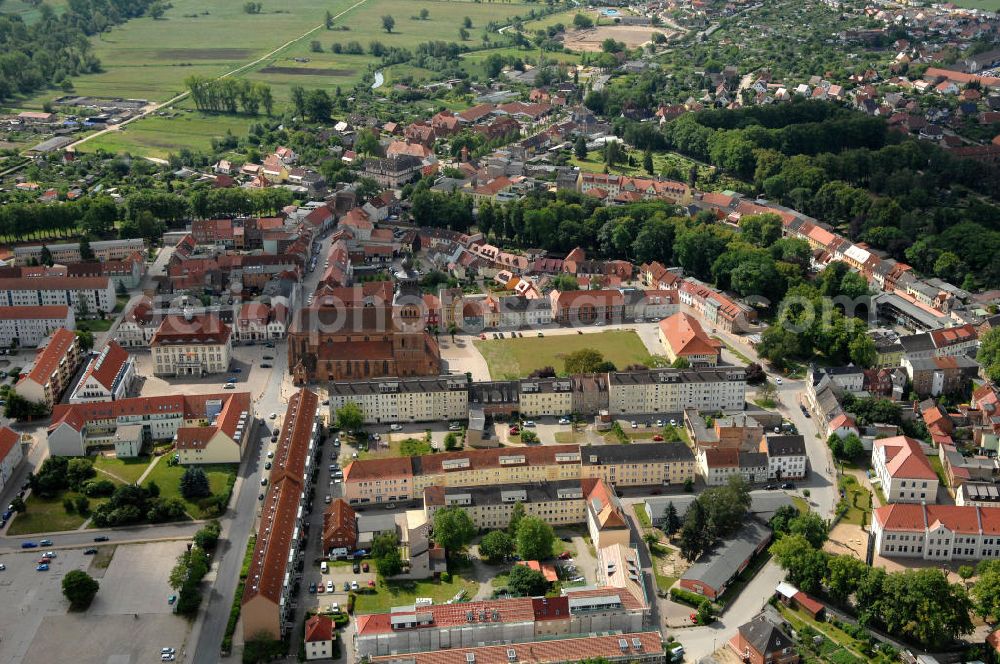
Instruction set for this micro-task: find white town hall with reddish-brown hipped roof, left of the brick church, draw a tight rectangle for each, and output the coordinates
[149,312,232,376]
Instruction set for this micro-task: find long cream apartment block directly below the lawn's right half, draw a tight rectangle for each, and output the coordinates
[608,367,746,415]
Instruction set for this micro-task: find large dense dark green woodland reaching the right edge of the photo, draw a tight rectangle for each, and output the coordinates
[588,95,1000,289]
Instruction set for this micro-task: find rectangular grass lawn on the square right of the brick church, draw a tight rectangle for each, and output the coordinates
[474,330,649,380]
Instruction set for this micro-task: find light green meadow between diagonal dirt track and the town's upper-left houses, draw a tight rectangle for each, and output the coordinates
[77,101,254,159]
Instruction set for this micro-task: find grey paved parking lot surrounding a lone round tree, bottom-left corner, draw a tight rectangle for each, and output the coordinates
[0,542,190,664]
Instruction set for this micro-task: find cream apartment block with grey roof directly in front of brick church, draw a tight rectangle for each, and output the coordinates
[329,376,469,424]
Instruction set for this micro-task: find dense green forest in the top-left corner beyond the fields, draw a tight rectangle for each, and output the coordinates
[0,0,158,102]
